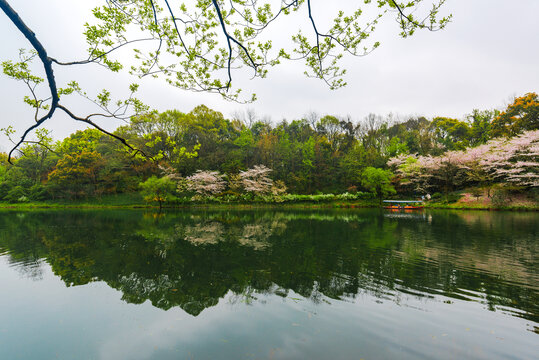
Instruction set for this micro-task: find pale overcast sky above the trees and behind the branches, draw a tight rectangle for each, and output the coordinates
[0,0,539,151]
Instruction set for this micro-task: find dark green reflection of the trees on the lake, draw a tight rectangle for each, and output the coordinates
[0,210,539,322]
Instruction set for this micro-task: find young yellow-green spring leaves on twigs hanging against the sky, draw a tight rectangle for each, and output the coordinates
[0,0,451,157]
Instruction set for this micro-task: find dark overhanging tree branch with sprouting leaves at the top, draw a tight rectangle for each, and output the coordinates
[0,0,450,159]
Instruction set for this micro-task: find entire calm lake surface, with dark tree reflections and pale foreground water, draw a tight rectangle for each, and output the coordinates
[0,210,539,360]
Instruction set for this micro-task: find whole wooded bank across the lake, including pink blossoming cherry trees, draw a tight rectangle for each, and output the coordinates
[0,93,539,206]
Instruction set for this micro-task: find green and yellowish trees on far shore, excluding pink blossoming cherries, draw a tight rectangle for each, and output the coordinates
[0,93,539,202]
